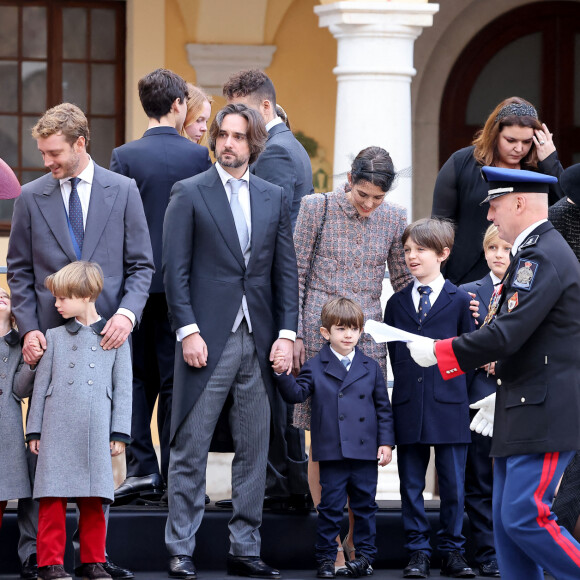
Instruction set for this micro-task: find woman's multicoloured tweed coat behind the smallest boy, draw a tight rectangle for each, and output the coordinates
[294,187,411,429]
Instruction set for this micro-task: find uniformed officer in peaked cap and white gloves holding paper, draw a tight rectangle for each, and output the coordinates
[409,167,580,580]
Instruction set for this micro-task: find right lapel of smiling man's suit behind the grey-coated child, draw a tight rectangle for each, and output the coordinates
[81,163,119,260]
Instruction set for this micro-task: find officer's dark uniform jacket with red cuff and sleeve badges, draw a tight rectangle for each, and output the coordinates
[437,222,580,457]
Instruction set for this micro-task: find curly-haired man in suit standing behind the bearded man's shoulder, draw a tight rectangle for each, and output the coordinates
[222,70,314,509]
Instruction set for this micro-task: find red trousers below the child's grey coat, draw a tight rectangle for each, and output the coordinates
[36,497,107,566]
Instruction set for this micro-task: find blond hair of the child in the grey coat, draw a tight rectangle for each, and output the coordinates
[44,261,103,302]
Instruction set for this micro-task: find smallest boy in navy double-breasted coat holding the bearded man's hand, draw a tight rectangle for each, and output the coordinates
[273,298,394,578]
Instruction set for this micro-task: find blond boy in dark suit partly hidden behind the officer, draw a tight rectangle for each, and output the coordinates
[460,224,512,578]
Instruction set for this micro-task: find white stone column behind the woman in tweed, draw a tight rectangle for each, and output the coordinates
[314,0,439,220]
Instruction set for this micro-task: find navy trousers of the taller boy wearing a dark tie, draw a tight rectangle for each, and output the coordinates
[398,443,467,557]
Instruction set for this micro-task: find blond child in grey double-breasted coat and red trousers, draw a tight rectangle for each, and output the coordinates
[26,262,132,580]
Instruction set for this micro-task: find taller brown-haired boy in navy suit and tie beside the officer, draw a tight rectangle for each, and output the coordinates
[385,219,475,578]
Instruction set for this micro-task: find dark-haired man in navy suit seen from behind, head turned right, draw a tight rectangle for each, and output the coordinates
[111,69,211,505]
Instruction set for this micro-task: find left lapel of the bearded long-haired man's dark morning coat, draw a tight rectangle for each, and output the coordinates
[199,166,246,270]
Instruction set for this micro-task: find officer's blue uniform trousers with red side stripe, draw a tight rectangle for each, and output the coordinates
[493,451,580,580]
